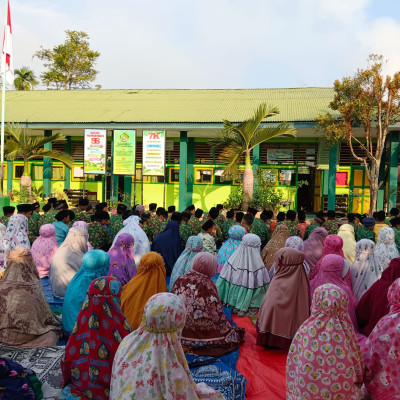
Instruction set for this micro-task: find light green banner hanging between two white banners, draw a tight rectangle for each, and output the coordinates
[113,130,136,175]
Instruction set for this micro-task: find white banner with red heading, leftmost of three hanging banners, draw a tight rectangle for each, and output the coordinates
[84,129,107,174]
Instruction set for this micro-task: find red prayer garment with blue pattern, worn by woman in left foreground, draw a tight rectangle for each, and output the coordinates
[61,276,131,400]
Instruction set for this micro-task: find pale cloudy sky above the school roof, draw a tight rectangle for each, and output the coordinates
[7,0,400,89]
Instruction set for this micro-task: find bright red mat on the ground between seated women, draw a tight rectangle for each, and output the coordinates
[233,315,287,400]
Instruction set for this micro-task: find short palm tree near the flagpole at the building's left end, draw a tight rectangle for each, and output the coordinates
[4,124,74,196]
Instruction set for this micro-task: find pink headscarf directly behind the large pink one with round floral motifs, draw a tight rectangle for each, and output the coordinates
[310,255,358,331]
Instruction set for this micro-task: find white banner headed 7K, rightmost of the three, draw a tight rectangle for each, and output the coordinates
[142,131,165,176]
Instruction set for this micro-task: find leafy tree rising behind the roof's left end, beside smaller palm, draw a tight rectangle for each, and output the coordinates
[34,31,100,90]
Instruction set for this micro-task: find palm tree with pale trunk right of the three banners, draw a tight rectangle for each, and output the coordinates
[209,103,297,209]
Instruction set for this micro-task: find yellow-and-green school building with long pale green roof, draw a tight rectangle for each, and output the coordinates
[5,88,400,213]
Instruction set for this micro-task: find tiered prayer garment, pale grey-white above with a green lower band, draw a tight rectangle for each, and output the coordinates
[217,233,270,312]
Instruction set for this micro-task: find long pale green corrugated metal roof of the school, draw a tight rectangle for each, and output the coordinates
[6,88,333,123]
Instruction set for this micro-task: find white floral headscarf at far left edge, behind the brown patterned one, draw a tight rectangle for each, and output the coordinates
[0,214,31,265]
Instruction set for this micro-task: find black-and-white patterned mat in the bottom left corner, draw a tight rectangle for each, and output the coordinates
[0,343,65,400]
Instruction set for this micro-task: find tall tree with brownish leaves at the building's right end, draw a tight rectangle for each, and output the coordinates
[316,54,400,215]
